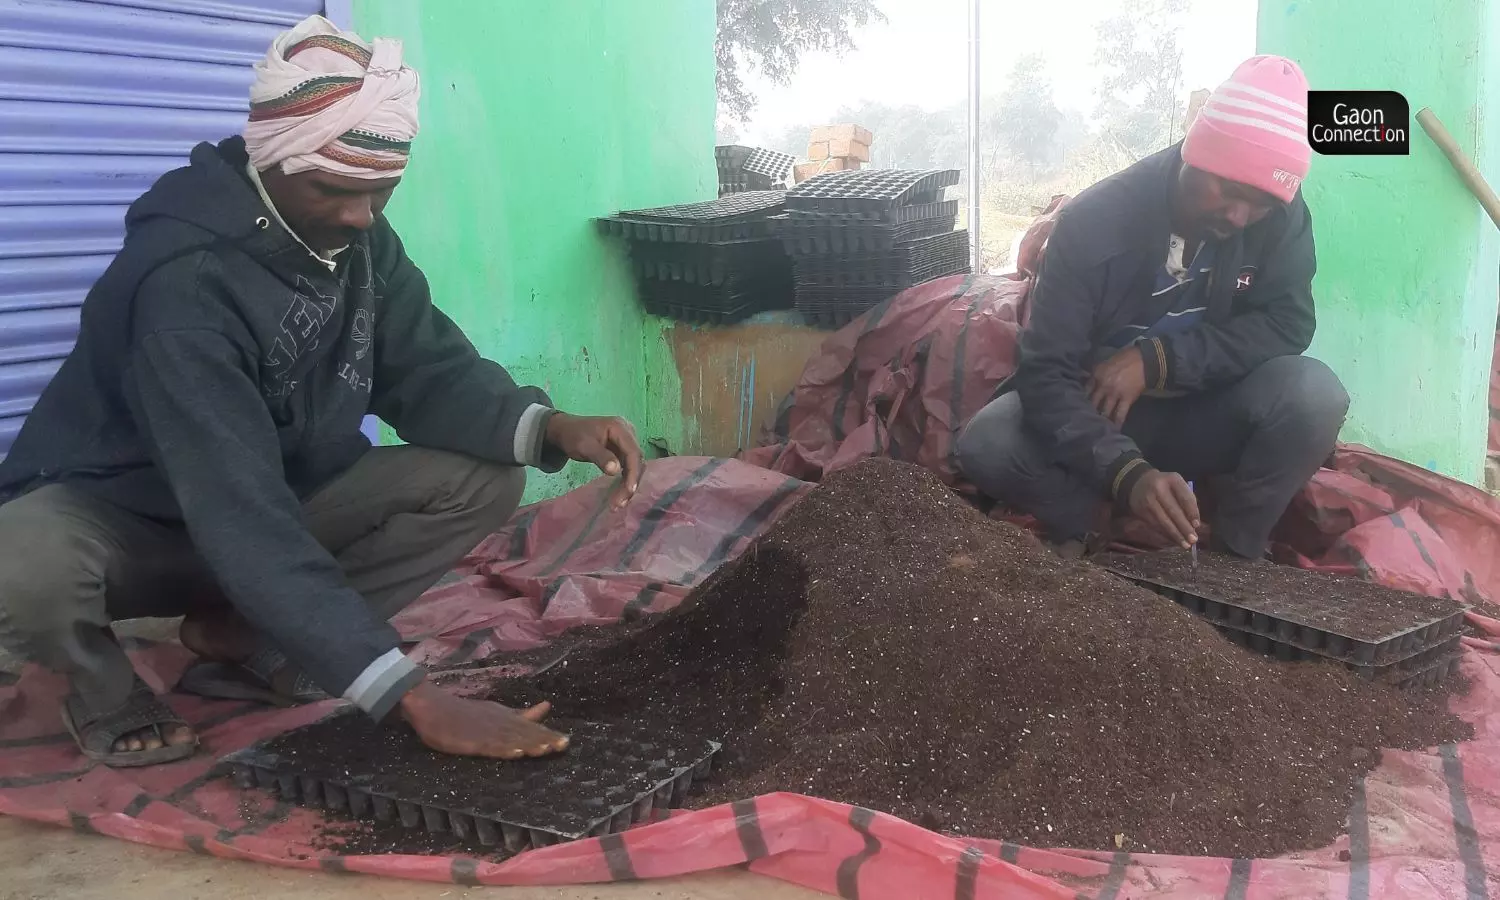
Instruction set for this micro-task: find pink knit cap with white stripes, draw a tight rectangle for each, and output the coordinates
[1182,56,1313,203]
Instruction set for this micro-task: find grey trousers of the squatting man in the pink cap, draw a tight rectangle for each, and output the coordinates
[957,357,1349,558]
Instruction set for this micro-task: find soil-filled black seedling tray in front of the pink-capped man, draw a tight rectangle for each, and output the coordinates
[1098,551,1469,669]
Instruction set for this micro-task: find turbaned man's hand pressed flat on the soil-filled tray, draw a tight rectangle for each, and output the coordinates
[401,681,567,759]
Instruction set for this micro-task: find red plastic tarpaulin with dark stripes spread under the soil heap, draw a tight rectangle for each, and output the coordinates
[0,264,1500,900]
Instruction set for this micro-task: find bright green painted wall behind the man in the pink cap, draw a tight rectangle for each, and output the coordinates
[1259,0,1500,483]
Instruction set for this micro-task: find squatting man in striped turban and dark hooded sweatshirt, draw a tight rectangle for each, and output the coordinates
[0,17,642,765]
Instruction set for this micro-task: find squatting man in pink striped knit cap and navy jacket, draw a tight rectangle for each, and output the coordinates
[957,56,1349,558]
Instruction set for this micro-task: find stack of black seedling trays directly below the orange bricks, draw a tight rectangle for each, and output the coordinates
[774,170,969,327]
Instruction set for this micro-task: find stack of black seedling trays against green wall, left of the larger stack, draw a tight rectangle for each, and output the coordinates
[599,191,792,324]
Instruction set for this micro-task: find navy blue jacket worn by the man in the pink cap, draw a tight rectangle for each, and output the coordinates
[1004,144,1316,498]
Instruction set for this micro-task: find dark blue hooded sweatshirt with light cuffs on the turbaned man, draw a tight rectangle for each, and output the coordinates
[0,138,563,716]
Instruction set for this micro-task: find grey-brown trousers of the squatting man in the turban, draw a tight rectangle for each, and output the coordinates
[0,447,527,710]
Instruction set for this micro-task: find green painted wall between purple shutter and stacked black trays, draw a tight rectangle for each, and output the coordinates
[354,0,717,500]
